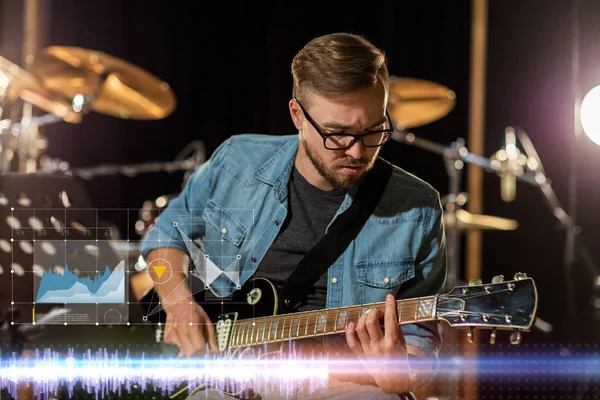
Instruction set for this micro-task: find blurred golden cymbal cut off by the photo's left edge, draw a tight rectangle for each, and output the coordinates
[0,57,81,123]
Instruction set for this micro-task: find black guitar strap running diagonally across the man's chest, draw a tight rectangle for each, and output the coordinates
[279,158,392,313]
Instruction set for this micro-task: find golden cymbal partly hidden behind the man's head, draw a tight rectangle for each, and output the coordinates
[388,77,456,129]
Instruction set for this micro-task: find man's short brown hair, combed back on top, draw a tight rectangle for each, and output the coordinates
[292,33,389,101]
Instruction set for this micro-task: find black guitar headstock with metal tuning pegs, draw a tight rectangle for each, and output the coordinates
[437,272,537,344]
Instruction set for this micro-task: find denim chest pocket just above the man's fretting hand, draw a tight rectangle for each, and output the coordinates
[356,258,415,304]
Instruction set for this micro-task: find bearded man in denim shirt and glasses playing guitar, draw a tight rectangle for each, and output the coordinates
[142,33,446,399]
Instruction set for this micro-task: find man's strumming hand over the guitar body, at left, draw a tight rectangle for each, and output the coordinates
[164,302,218,357]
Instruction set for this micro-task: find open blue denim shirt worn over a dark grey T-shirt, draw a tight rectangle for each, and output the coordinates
[142,134,446,360]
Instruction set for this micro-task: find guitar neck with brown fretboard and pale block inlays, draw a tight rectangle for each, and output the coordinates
[229,296,437,348]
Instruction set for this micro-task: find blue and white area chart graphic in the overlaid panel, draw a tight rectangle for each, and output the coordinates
[35,261,125,304]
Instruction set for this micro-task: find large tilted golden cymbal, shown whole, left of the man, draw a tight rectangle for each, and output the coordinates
[31,46,176,120]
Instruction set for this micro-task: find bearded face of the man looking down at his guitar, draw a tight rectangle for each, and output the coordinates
[290,84,388,189]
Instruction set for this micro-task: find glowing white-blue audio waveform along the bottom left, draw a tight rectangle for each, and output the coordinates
[0,349,329,399]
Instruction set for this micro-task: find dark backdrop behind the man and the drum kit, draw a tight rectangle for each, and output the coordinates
[0,0,600,396]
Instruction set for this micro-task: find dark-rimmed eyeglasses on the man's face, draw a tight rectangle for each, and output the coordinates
[294,97,394,150]
